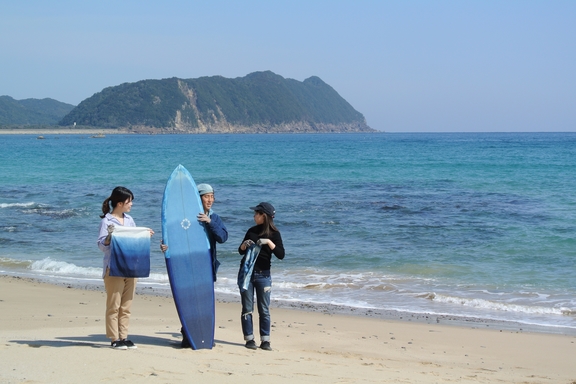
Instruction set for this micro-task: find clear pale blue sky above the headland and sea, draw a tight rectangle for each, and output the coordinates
[0,0,576,132]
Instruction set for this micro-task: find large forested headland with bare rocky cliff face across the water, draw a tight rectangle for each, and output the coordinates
[59,71,374,133]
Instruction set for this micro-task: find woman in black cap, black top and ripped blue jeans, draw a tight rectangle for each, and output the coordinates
[238,202,284,351]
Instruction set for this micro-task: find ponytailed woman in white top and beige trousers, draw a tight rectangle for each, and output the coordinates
[98,187,154,349]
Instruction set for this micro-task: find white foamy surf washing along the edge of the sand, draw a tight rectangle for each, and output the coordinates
[0,255,576,333]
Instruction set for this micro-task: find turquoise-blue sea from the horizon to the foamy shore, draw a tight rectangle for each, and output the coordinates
[0,133,576,329]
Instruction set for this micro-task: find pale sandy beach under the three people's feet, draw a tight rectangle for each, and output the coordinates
[0,276,576,384]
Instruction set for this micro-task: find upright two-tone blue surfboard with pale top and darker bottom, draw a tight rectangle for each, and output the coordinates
[162,165,215,349]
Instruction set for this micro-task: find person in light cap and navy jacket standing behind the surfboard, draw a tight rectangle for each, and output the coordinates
[160,184,228,348]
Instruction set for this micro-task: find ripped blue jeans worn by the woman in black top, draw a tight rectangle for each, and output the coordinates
[240,271,272,341]
